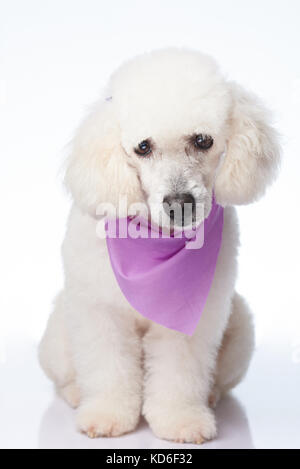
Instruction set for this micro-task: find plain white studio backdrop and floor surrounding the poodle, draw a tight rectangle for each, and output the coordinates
[0,0,300,448]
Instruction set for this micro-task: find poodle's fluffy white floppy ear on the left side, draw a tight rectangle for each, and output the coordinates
[65,101,140,216]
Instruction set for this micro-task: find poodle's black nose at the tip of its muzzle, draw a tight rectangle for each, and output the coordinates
[163,192,196,225]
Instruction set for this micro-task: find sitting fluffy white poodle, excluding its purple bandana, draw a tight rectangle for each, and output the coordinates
[39,49,280,443]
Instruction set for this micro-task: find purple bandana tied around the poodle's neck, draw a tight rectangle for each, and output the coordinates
[106,201,223,335]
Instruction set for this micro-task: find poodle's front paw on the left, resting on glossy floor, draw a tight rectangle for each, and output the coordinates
[76,399,140,438]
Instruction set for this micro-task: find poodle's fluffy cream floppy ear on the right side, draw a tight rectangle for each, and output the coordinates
[215,83,280,206]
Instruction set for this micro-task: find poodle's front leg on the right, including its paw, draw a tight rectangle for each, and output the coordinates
[143,315,227,443]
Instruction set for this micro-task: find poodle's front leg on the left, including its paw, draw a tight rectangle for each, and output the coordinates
[68,297,142,438]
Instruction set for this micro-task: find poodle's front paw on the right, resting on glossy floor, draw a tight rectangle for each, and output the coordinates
[145,400,217,444]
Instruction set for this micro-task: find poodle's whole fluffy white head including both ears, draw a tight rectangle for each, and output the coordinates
[66,49,279,226]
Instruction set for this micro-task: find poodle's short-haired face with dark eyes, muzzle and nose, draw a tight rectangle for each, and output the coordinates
[124,137,219,228]
